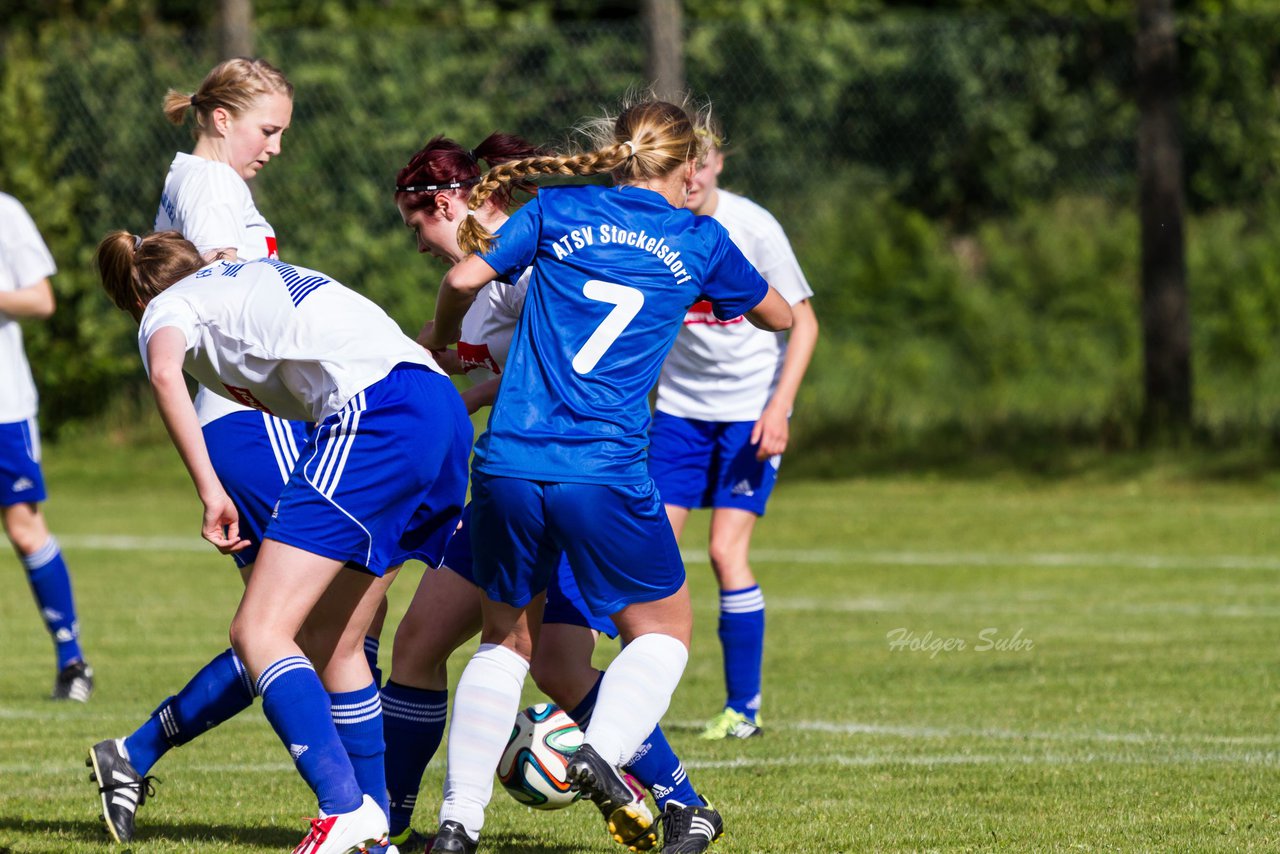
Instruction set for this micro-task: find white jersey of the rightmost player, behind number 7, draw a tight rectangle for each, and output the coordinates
[657,189,813,421]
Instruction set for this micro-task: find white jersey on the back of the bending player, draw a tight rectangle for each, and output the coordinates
[138,259,443,421]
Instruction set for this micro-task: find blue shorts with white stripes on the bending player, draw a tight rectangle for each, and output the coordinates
[266,365,471,576]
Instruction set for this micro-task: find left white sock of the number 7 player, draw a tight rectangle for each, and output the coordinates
[440,644,529,834]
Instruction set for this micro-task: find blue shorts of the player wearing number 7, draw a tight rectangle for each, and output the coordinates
[471,472,685,617]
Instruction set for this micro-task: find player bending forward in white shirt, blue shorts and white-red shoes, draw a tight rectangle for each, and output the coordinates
[96,232,471,854]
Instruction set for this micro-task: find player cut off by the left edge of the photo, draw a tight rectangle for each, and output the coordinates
[0,193,93,703]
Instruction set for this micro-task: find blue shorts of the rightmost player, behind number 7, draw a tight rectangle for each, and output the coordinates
[649,412,782,516]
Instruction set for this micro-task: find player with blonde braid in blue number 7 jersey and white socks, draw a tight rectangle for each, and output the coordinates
[424,101,791,853]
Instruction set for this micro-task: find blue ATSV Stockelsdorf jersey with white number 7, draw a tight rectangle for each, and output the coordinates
[475,186,769,484]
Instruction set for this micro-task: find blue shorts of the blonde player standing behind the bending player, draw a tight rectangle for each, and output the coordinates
[202,410,311,566]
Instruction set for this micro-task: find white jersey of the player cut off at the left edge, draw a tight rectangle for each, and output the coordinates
[0,193,58,424]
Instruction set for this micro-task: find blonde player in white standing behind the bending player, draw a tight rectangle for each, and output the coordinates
[88,58,355,842]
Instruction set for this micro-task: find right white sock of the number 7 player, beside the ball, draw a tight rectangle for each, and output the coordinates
[584,634,689,766]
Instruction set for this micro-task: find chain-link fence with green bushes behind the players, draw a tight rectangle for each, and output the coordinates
[40,14,1280,453]
